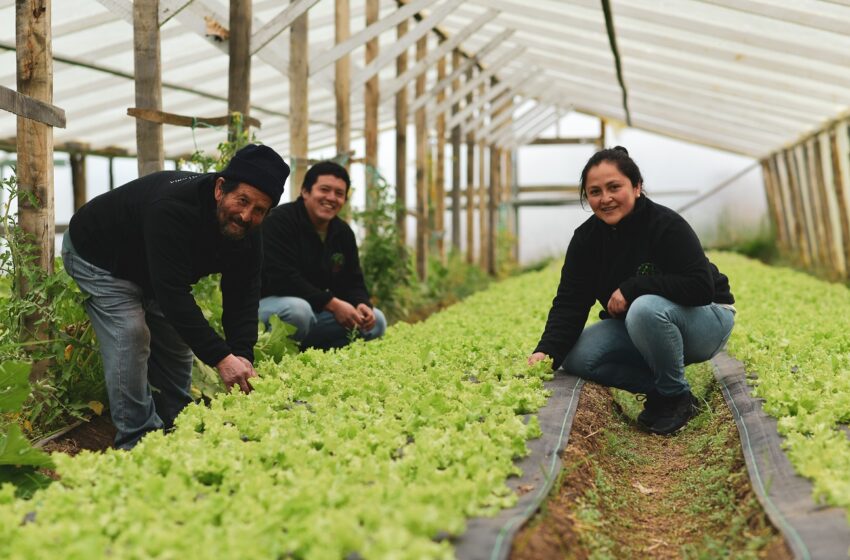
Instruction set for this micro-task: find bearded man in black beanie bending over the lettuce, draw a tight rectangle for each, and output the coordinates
[62,145,289,449]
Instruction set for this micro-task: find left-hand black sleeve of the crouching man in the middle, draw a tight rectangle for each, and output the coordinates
[263,210,333,311]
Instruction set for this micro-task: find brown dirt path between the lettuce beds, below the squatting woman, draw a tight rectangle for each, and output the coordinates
[511,383,793,560]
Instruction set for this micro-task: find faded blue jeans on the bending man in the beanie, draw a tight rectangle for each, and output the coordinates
[62,232,192,449]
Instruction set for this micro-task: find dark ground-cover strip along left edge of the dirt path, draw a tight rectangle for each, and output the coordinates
[454,371,584,560]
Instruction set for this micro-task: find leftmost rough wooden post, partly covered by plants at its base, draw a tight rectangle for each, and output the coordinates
[15,0,56,370]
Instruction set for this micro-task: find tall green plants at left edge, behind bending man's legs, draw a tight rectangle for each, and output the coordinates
[0,173,106,434]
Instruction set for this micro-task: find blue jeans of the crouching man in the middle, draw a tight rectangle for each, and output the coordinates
[259,296,387,350]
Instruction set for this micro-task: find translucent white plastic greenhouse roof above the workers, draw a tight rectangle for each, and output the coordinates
[0,0,850,158]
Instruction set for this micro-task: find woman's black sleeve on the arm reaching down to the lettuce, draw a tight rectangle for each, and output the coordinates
[534,236,594,369]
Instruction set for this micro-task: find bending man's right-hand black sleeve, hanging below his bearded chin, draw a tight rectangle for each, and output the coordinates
[221,235,263,363]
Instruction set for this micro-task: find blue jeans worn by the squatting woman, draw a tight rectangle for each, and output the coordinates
[561,295,735,396]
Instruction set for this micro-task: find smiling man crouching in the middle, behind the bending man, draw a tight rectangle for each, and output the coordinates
[259,161,386,350]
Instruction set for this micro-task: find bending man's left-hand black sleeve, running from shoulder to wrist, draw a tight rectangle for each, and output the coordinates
[144,202,231,366]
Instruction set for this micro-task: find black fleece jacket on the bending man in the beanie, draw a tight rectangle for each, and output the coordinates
[69,171,262,366]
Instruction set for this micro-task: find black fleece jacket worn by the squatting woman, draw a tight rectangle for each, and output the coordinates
[534,196,735,368]
